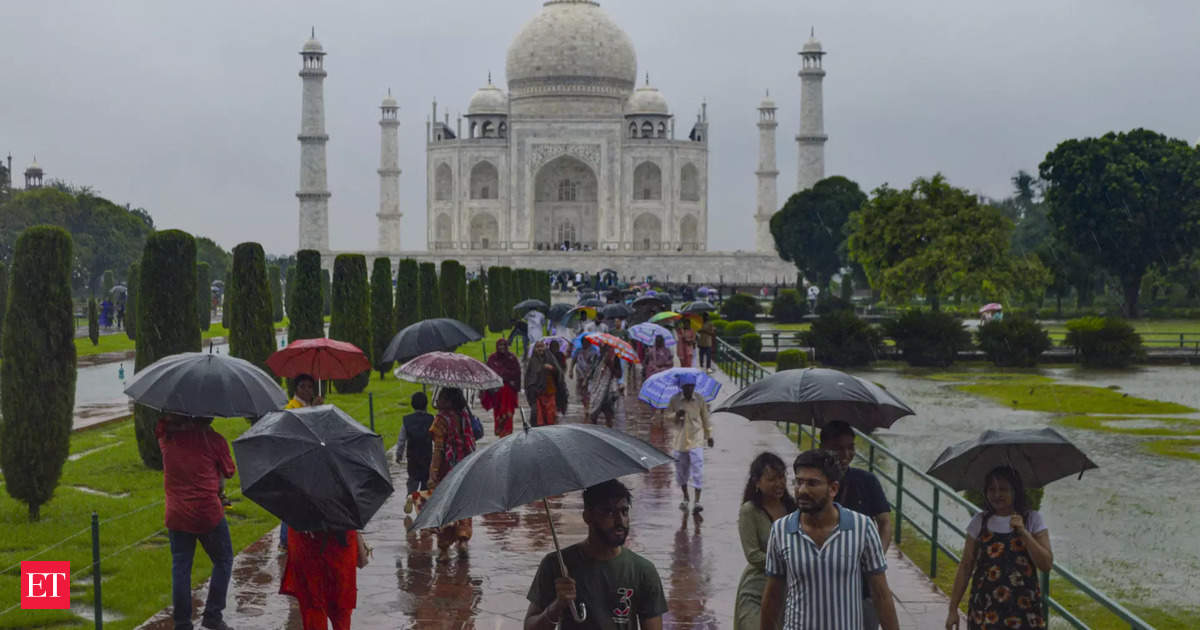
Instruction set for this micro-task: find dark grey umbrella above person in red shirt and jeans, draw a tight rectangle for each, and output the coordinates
[125,352,288,418]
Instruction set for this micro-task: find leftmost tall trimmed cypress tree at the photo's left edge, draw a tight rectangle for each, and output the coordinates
[0,226,76,521]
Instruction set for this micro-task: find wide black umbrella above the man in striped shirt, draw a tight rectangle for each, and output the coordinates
[714,367,913,431]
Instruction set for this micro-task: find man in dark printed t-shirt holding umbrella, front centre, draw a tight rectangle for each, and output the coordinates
[524,480,667,630]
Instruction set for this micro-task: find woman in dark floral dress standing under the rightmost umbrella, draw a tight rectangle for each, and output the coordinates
[946,466,1054,630]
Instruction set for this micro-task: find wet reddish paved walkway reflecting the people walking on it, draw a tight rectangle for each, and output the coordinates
[143,364,947,630]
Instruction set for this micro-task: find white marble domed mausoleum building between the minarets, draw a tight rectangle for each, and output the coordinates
[426,0,708,254]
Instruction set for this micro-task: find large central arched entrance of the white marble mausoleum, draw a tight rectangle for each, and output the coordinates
[533,156,600,250]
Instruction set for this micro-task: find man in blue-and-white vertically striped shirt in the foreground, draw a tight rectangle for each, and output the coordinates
[762,450,900,630]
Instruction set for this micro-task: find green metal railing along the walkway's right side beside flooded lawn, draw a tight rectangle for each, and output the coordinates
[715,340,1153,630]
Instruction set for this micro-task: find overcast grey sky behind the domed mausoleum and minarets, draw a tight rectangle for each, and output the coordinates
[0,0,1200,253]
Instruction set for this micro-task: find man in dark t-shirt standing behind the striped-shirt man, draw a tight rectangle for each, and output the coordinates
[821,420,892,630]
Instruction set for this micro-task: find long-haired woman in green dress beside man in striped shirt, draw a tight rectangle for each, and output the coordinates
[733,452,796,630]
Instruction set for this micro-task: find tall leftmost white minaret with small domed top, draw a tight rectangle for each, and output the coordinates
[296,29,329,252]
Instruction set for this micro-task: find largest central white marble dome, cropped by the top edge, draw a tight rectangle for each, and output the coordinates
[506,0,637,96]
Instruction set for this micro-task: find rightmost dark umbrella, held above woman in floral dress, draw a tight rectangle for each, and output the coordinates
[929,427,1098,490]
